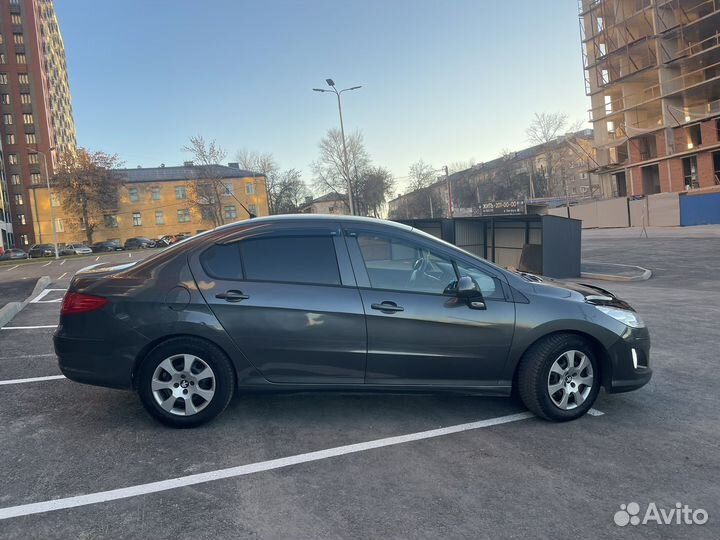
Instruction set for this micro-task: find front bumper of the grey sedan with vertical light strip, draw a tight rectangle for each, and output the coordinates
[604,328,652,393]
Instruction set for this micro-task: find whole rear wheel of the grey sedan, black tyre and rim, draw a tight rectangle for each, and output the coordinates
[136,338,235,428]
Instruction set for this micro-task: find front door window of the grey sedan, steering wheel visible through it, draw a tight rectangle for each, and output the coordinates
[357,234,457,294]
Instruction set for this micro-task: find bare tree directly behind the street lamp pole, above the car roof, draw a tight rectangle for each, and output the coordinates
[312,128,370,213]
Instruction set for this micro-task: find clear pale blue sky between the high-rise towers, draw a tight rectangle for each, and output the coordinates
[55,0,589,195]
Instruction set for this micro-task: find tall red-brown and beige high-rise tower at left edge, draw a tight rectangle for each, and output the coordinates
[0,0,75,248]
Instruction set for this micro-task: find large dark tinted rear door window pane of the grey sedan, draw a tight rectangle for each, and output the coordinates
[238,235,341,285]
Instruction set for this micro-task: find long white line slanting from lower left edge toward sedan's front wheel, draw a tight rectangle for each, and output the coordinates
[0,412,534,520]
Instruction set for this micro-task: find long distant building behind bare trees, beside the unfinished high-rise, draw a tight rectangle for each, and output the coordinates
[388,129,600,219]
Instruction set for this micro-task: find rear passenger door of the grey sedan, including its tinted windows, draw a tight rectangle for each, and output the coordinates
[191,222,367,384]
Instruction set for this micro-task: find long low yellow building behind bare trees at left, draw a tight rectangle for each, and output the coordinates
[28,162,268,243]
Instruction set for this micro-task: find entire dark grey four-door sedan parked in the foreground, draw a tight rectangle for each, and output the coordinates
[54,215,652,427]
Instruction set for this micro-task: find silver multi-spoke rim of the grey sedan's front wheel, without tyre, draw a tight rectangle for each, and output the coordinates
[547,350,595,411]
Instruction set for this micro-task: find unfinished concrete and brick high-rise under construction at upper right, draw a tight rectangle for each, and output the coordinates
[579,0,720,196]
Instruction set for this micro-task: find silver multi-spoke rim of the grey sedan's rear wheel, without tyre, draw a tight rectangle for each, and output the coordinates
[151,354,216,416]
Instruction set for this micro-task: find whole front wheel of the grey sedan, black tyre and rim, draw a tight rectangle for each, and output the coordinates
[516,334,600,422]
